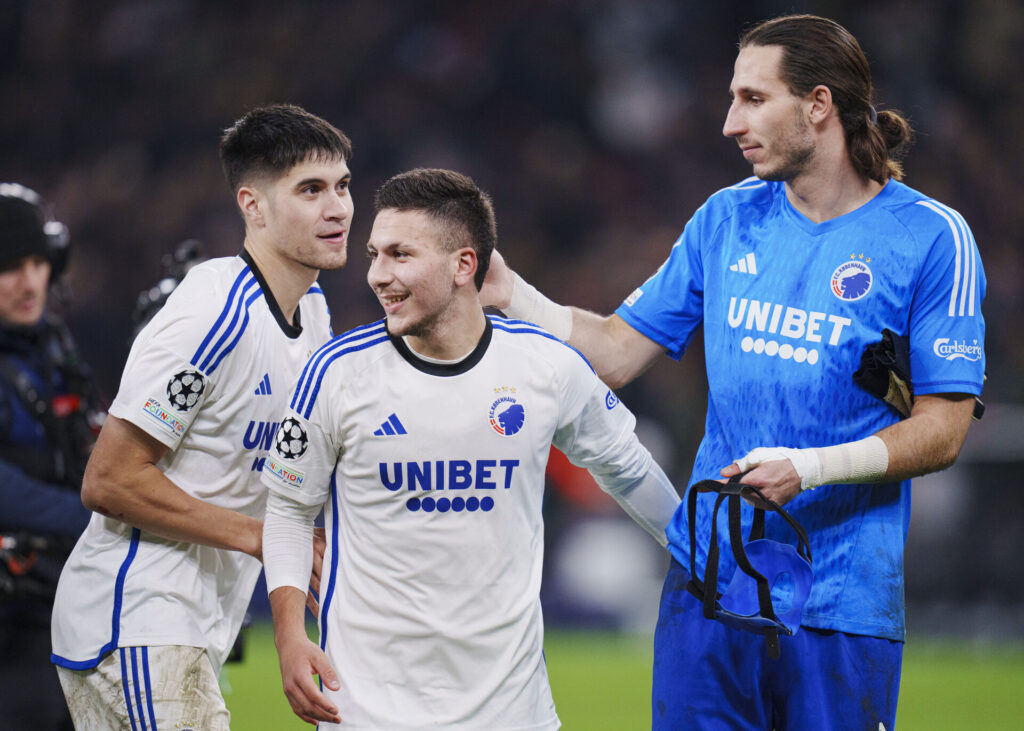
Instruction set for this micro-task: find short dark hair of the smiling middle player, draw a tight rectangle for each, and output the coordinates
[374,168,498,289]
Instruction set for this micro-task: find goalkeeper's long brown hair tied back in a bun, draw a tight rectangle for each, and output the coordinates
[739,15,913,184]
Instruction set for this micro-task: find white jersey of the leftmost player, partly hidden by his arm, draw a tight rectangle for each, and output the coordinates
[52,252,331,670]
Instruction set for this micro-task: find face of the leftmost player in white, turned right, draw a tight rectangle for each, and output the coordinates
[245,159,354,269]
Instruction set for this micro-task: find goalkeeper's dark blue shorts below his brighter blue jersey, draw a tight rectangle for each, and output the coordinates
[651,560,903,731]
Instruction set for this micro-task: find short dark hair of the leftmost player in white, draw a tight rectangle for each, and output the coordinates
[220,104,352,192]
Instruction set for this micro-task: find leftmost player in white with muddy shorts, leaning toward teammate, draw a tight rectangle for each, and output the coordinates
[52,105,353,731]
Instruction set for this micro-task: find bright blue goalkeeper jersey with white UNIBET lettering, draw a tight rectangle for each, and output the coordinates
[616,178,985,640]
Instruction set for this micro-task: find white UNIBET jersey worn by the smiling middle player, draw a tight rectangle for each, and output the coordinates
[262,317,652,731]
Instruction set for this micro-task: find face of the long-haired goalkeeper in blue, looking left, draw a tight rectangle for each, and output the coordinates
[722,45,815,182]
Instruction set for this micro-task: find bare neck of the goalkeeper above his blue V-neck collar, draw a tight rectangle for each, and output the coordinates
[785,144,883,223]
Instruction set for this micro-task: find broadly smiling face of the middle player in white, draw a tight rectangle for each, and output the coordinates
[367,208,472,341]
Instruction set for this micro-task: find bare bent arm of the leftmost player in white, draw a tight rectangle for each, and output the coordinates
[82,416,263,560]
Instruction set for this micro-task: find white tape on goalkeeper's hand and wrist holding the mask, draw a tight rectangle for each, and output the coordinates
[736,436,889,489]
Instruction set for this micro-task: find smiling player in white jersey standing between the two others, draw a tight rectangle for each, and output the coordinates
[262,169,679,731]
